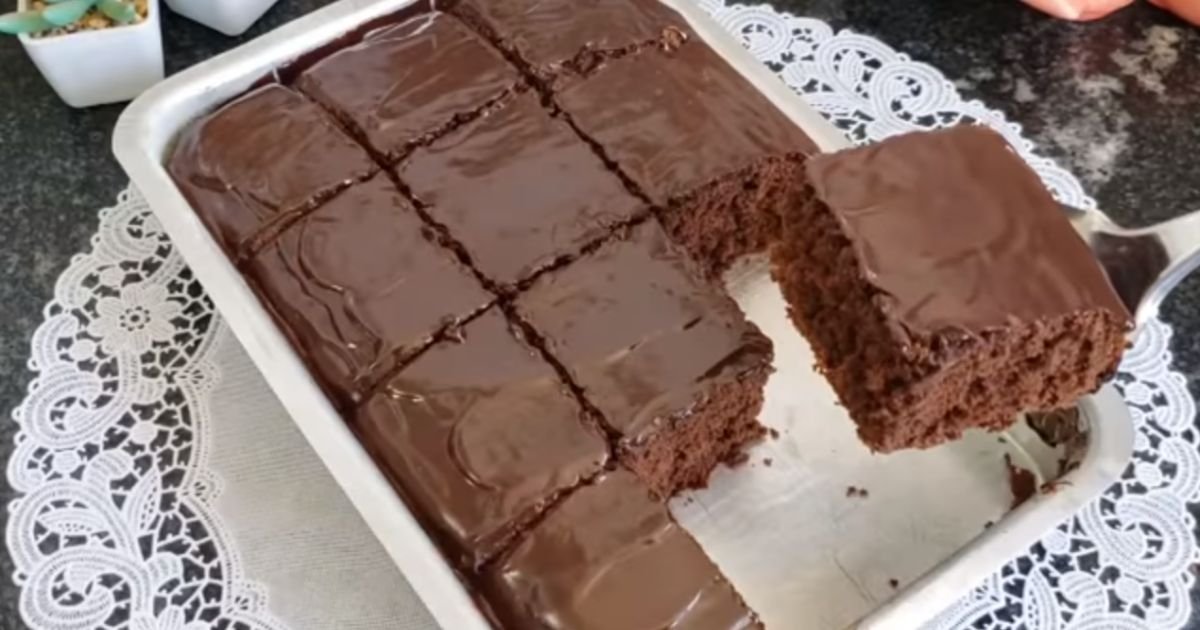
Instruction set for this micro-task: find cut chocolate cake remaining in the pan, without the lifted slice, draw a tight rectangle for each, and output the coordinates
[168,0,835,630]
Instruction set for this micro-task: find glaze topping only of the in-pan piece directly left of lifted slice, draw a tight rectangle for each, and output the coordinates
[557,41,816,205]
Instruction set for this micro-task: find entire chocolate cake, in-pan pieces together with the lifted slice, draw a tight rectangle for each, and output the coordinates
[168,0,1129,630]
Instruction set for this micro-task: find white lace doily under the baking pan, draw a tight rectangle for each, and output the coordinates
[7,0,1200,630]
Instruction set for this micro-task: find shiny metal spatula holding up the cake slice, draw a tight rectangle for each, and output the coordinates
[1062,205,1200,329]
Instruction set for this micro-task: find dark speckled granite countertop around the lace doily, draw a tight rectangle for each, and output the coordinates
[0,0,1200,630]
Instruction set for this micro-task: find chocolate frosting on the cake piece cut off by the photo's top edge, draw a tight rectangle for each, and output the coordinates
[458,0,688,71]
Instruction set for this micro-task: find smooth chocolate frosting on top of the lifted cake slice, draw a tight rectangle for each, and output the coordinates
[808,126,1129,335]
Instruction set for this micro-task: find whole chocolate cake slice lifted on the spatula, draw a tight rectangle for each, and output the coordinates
[772,127,1130,452]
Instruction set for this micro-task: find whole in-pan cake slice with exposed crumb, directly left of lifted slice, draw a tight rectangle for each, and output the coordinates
[556,40,816,277]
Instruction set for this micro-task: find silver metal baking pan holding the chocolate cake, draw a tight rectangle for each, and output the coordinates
[113,0,1133,630]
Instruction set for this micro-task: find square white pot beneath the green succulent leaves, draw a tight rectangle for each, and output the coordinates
[17,0,164,107]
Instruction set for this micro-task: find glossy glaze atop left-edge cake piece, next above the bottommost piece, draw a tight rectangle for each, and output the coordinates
[354,307,607,569]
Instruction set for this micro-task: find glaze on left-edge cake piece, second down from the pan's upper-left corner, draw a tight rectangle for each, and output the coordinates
[247,175,492,402]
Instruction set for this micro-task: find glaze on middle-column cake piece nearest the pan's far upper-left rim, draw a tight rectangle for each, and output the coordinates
[295,13,520,158]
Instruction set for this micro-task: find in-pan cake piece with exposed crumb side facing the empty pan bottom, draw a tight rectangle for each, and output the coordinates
[515,222,772,497]
